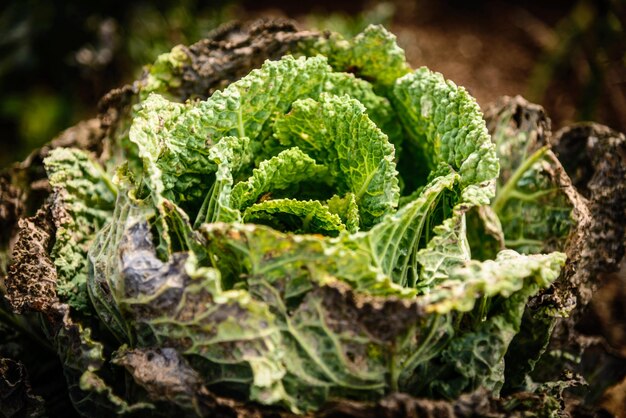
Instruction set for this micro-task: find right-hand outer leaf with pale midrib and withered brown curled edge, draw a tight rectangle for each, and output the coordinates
[486,96,588,391]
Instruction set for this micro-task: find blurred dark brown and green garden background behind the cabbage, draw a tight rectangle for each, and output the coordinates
[0,0,626,168]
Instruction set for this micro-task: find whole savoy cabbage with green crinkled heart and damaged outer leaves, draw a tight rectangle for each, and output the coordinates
[2,22,608,416]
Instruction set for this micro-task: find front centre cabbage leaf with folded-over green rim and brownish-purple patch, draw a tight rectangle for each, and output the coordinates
[202,224,422,410]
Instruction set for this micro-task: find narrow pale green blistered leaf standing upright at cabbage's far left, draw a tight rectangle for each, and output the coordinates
[44,148,117,311]
